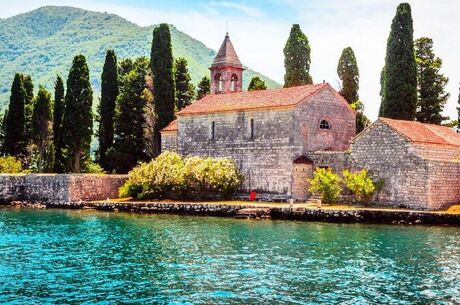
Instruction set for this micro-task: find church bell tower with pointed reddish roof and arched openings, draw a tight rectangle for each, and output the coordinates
[209,33,244,93]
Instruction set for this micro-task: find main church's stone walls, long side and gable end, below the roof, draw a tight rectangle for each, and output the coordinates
[174,86,355,196]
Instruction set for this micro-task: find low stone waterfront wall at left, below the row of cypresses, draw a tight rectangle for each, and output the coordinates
[0,174,127,202]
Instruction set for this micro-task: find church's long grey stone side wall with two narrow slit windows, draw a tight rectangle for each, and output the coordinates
[178,108,301,194]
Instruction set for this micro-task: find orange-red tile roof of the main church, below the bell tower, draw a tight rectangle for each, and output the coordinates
[177,84,344,116]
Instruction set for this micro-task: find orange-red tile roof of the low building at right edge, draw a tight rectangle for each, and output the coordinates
[380,118,460,147]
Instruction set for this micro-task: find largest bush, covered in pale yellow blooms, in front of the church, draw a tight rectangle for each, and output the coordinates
[119,152,242,200]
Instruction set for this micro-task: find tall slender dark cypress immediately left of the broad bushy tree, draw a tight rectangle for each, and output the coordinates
[98,50,119,171]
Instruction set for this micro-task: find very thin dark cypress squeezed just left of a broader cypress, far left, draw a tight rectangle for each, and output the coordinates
[53,75,65,173]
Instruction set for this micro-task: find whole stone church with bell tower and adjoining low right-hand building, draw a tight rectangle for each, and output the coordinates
[161,34,460,209]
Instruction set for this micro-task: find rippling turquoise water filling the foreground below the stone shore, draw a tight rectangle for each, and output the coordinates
[0,208,460,304]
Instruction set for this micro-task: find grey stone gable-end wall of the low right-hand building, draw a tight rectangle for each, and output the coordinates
[350,121,429,208]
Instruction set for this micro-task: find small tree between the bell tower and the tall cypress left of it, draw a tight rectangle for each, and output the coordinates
[174,57,195,110]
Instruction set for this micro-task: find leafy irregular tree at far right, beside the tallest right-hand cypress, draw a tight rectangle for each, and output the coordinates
[415,37,449,125]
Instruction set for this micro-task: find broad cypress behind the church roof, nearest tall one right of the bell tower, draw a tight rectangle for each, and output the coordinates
[284,24,313,88]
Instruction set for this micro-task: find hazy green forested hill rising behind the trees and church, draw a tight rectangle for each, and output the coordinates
[0,6,279,108]
